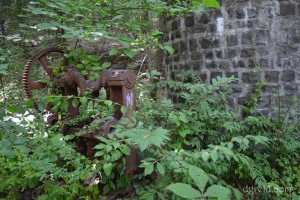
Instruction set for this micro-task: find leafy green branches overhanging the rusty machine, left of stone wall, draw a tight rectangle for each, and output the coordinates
[20,0,220,58]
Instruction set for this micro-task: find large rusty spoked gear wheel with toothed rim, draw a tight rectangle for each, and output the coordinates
[23,47,67,112]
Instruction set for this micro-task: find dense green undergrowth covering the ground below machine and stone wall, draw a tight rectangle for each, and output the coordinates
[0,71,300,199]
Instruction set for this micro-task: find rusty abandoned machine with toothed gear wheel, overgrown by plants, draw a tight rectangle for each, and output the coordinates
[23,47,137,174]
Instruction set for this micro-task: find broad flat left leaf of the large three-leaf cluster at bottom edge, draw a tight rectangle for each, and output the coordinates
[166,183,201,199]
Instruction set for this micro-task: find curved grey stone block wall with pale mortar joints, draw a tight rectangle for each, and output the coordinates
[161,0,300,115]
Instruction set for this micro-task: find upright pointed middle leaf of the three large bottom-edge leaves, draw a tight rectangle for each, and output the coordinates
[189,165,208,193]
